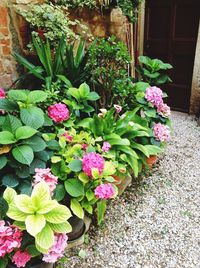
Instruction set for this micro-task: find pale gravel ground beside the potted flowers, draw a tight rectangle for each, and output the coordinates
[65,112,200,268]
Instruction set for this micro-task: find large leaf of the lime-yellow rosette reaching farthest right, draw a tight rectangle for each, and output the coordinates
[44,205,72,224]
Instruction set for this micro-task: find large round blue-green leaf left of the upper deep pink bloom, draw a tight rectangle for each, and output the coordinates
[20,107,44,129]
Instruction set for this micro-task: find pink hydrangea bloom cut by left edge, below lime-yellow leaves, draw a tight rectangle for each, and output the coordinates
[0,221,23,257]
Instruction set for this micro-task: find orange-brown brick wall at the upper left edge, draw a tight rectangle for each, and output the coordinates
[0,1,16,87]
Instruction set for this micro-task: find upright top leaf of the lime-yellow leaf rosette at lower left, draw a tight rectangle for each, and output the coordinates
[31,181,51,210]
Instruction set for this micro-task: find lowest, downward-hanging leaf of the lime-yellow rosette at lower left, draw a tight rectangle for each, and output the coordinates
[35,224,54,251]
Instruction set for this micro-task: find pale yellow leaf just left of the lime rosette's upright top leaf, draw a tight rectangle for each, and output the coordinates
[15,194,36,214]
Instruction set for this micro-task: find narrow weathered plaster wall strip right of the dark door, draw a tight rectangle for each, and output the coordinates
[190,24,200,114]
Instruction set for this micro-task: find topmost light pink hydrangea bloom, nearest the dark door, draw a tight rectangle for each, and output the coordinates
[145,87,163,107]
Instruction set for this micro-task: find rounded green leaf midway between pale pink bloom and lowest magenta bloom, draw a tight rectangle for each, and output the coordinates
[64,179,84,197]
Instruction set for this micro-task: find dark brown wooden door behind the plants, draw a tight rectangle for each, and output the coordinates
[144,0,200,112]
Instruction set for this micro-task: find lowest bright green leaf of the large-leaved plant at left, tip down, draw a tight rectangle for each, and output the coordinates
[12,145,34,166]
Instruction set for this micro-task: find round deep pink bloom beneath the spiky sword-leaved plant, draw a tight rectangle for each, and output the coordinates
[48,103,69,122]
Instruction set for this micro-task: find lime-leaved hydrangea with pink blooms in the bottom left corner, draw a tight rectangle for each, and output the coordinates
[0,181,71,268]
